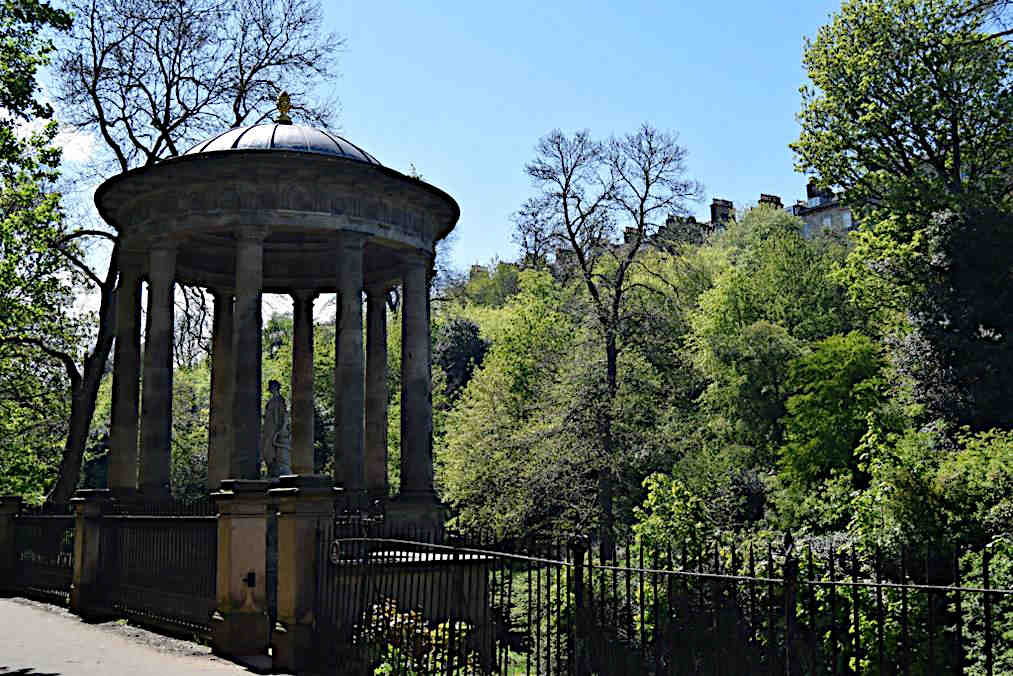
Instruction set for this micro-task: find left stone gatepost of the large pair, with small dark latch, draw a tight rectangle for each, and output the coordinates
[211,479,269,658]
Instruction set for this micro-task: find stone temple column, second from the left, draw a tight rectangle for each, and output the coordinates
[138,242,176,500]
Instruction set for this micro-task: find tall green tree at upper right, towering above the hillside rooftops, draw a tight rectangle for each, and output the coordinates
[792,0,1013,430]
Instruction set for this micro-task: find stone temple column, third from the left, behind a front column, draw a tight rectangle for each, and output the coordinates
[208,289,239,490]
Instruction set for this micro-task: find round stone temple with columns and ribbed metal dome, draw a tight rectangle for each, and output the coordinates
[95,96,460,521]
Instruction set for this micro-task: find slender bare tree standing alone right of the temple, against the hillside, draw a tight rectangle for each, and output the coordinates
[517,124,701,558]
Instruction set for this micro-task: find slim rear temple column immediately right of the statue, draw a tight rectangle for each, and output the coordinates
[292,290,316,474]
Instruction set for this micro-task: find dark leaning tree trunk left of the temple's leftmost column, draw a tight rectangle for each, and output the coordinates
[46,251,119,505]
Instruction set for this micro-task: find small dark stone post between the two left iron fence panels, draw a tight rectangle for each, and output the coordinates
[70,489,112,620]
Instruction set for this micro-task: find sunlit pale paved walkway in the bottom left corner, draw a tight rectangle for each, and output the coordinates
[0,599,250,676]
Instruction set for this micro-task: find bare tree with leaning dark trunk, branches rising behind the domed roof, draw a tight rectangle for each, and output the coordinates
[34,0,343,504]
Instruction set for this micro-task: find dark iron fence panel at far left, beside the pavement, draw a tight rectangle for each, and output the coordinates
[14,509,74,605]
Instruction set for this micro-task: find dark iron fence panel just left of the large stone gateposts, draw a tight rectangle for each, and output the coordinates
[99,513,218,635]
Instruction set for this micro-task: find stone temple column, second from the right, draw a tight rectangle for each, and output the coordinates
[366,286,388,501]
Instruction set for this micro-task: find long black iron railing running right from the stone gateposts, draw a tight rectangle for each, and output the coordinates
[315,525,1013,676]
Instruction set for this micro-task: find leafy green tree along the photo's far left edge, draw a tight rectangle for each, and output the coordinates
[0,0,73,502]
